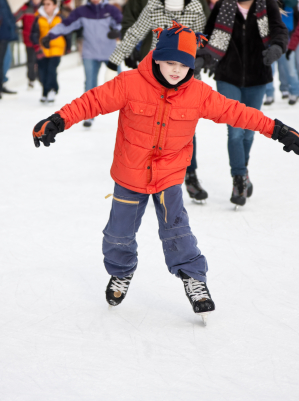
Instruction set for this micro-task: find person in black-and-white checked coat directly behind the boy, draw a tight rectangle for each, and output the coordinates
[108,0,210,202]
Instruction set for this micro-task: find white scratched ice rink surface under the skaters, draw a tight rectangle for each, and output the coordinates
[0,66,299,401]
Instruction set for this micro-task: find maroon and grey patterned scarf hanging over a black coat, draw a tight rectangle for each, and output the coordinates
[205,0,270,61]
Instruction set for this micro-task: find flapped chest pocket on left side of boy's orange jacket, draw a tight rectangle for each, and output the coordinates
[126,100,157,135]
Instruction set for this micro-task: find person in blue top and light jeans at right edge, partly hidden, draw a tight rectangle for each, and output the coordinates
[264,0,299,106]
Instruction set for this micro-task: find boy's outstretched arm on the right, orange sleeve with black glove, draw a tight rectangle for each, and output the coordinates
[201,85,299,155]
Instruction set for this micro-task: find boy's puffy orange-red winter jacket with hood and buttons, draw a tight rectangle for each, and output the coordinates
[57,52,274,194]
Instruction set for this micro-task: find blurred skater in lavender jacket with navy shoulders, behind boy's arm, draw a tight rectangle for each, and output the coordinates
[43,0,122,127]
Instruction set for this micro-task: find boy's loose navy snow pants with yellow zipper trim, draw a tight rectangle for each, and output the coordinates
[103,184,208,282]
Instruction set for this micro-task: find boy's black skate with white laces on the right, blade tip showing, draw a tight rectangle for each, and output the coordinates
[180,271,215,326]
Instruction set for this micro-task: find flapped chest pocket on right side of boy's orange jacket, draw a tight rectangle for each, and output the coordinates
[167,109,199,136]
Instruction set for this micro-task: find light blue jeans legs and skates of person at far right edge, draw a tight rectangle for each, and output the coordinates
[264,53,299,106]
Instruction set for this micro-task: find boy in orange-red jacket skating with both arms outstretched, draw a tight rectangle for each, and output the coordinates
[33,22,299,321]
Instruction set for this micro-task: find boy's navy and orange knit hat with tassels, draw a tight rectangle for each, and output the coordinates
[153,20,207,69]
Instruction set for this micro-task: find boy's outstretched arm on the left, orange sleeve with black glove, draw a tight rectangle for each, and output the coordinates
[33,74,126,148]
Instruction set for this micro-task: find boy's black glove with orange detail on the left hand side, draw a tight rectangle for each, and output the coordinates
[32,114,64,148]
